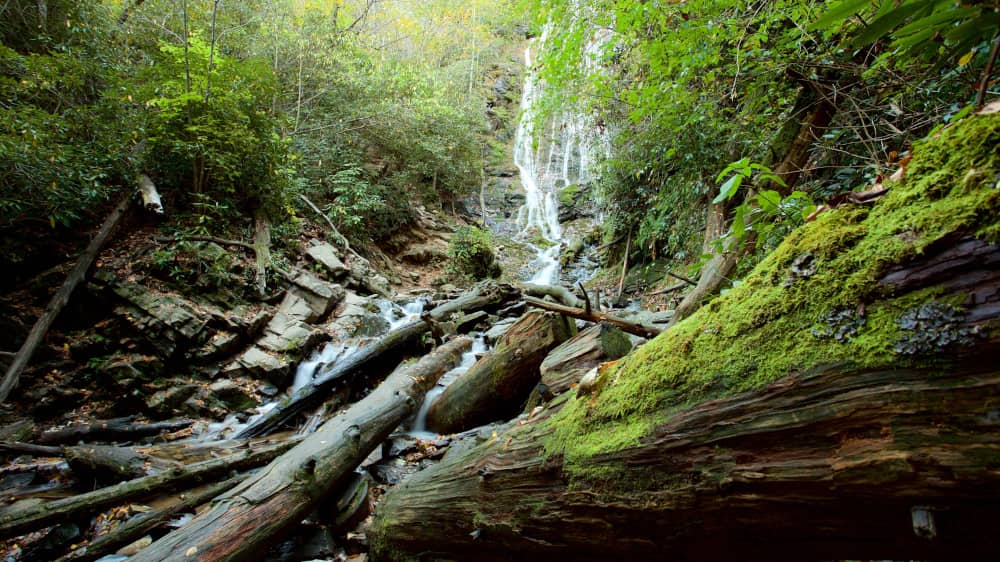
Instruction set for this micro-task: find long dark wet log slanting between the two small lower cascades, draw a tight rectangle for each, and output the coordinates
[237,283,514,439]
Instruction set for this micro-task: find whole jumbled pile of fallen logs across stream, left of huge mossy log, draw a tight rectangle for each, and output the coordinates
[0,278,656,560]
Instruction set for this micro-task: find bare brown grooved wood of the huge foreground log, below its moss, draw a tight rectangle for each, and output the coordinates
[369,356,1000,560]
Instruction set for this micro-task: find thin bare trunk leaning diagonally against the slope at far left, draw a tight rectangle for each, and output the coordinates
[0,196,131,403]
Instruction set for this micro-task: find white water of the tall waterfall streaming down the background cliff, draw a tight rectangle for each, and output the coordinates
[514,24,608,285]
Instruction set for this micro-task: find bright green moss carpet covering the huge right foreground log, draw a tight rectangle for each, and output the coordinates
[546,115,1000,480]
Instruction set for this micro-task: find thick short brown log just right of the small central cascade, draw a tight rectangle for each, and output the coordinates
[427,310,576,433]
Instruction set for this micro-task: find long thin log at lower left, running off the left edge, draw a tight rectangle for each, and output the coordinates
[0,439,298,538]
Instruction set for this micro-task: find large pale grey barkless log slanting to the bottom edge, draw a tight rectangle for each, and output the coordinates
[133,337,472,562]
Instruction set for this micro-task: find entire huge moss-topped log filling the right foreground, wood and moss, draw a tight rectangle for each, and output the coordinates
[369,116,1000,560]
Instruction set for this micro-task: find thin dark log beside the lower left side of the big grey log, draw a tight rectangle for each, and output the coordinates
[57,475,247,562]
